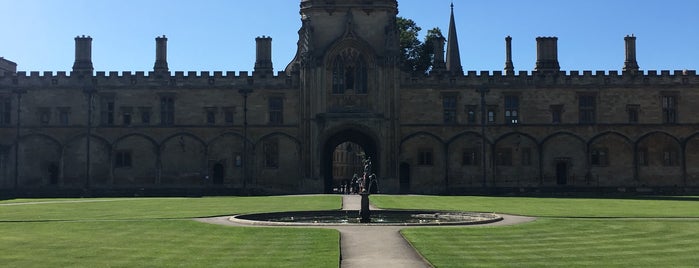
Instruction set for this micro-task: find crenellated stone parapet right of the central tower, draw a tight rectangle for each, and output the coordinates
[401,70,699,89]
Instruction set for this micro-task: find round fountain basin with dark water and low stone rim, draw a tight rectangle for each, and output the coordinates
[229,210,502,226]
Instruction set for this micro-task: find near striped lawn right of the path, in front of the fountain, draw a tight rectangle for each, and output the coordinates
[402,219,699,267]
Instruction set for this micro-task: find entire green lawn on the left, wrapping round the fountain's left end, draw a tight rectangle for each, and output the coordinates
[0,196,341,267]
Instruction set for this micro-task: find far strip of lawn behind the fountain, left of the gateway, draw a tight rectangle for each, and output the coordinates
[0,195,342,222]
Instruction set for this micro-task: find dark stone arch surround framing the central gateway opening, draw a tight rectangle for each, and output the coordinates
[320,128,381,193]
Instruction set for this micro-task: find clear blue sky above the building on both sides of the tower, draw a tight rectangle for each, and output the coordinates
[0,0,699,71]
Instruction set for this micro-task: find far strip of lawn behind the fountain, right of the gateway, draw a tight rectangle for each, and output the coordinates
[371,195,699,218]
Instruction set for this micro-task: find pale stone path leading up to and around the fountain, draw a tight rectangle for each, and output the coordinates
[197,195,535,268]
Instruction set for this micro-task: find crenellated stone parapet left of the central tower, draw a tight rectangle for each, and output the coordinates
[0,71,298,89]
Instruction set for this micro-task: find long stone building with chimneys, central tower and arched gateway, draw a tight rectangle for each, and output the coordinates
[0,0,699,195]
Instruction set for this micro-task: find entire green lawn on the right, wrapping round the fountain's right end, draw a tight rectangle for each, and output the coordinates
[372,196,699,267]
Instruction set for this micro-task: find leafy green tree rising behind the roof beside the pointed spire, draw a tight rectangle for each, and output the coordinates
[396,17,442,75]
